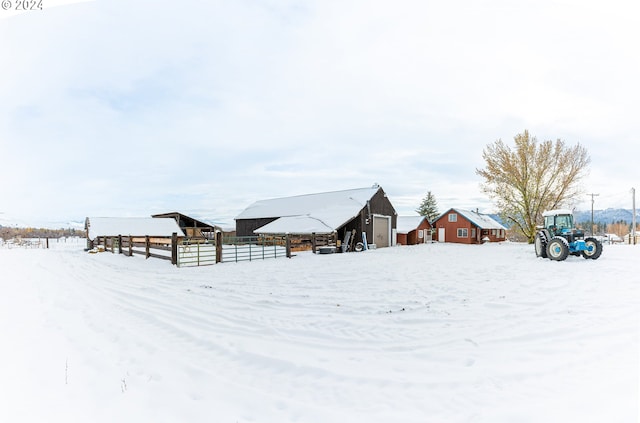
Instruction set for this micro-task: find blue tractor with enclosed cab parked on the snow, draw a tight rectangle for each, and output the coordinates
[534,210,602,261]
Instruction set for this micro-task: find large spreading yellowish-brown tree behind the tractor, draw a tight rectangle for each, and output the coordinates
[476,130,591,243]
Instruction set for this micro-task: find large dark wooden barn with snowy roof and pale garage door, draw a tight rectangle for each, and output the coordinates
[235,185,397,251]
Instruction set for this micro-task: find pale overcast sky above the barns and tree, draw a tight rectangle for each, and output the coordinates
[0,0,640,226]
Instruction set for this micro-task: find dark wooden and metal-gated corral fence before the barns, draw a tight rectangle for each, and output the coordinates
[88,232,292,267]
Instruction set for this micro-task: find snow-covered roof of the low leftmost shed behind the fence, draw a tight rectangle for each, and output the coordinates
[86,217,184,239]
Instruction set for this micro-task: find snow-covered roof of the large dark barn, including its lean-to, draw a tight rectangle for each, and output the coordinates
[236,186,380,233]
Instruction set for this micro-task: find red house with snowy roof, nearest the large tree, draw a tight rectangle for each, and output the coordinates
[433,208,507,244]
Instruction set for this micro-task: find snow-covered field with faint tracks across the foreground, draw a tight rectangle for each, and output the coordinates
[0,240,640,423]
